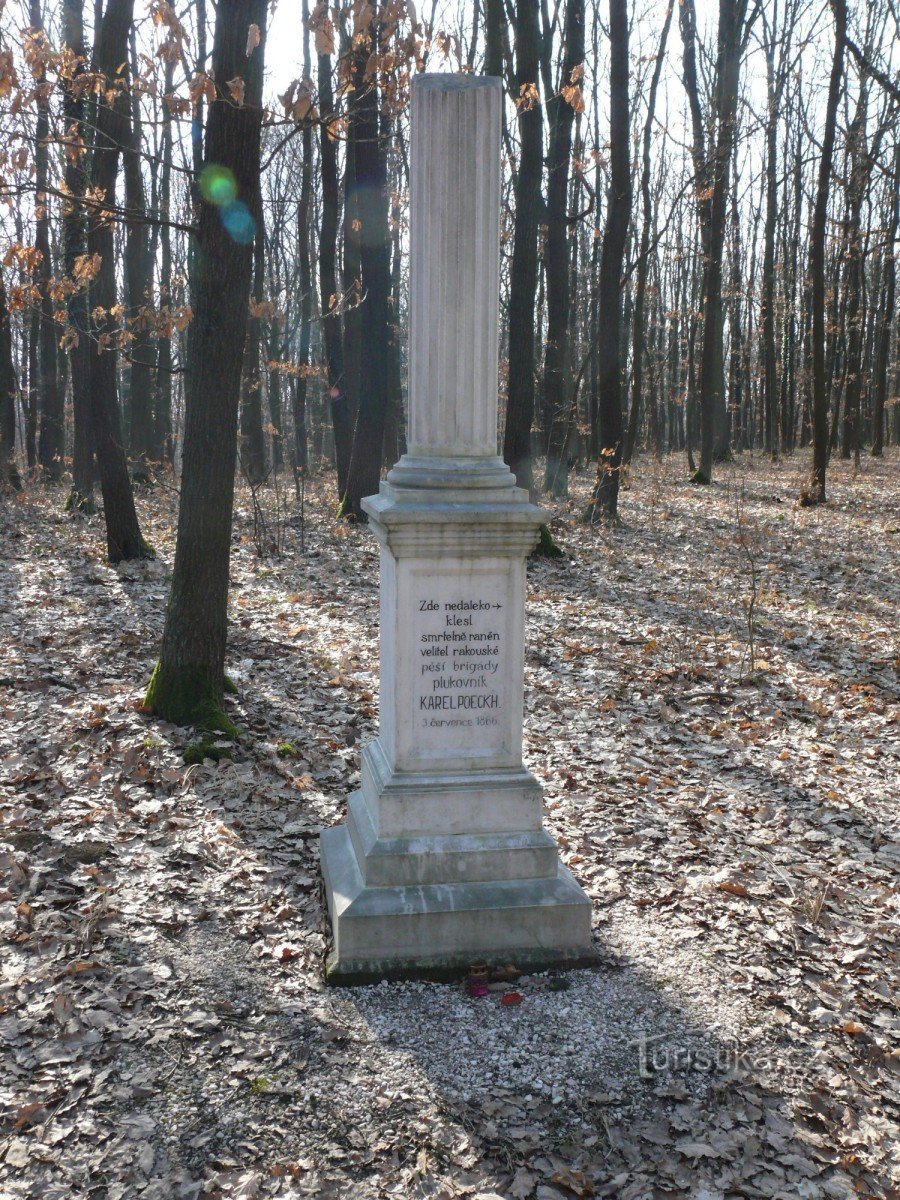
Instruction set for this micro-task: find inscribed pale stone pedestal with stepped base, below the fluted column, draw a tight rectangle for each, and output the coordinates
[322,460,592,983]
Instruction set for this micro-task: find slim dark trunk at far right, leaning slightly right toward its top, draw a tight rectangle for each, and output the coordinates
[800,0,847,504]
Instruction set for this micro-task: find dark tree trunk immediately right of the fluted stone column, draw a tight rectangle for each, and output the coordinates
[503,0,544,496]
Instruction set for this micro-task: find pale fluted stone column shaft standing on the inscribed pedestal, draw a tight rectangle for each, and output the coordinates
[408,74,503,458]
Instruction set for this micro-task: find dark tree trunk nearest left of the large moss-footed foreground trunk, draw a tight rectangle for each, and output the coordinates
[88,0,150,563]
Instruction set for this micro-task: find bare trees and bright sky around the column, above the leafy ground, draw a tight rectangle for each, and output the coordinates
[0,0,900,721]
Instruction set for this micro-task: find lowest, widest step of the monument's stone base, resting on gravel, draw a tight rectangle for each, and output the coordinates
[322,824,595,984]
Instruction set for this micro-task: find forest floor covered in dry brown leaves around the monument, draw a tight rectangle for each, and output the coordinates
[0,450,900,1200]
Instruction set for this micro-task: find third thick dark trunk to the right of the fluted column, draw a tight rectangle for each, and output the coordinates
[587,0,631,521]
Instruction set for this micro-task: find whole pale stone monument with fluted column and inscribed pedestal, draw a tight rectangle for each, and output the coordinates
[322,74,592,983]
